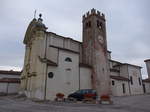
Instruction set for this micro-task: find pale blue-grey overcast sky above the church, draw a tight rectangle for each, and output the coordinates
[0,0,150,77]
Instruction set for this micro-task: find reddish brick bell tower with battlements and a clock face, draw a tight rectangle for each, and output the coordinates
[82,9,110,96]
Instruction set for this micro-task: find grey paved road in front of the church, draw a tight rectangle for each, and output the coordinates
[0,95,150,112]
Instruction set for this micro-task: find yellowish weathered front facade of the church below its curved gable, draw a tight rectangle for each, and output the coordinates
[21,31,47,99]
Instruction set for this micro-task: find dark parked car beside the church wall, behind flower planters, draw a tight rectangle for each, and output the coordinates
[68,89,97,101]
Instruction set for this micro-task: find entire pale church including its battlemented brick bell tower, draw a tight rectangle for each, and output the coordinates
[21,9,143,100]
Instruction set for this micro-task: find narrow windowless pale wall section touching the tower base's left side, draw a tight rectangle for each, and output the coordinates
[80,67,92,89]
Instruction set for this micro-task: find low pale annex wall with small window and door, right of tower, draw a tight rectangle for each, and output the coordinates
[111,79,130,96]
